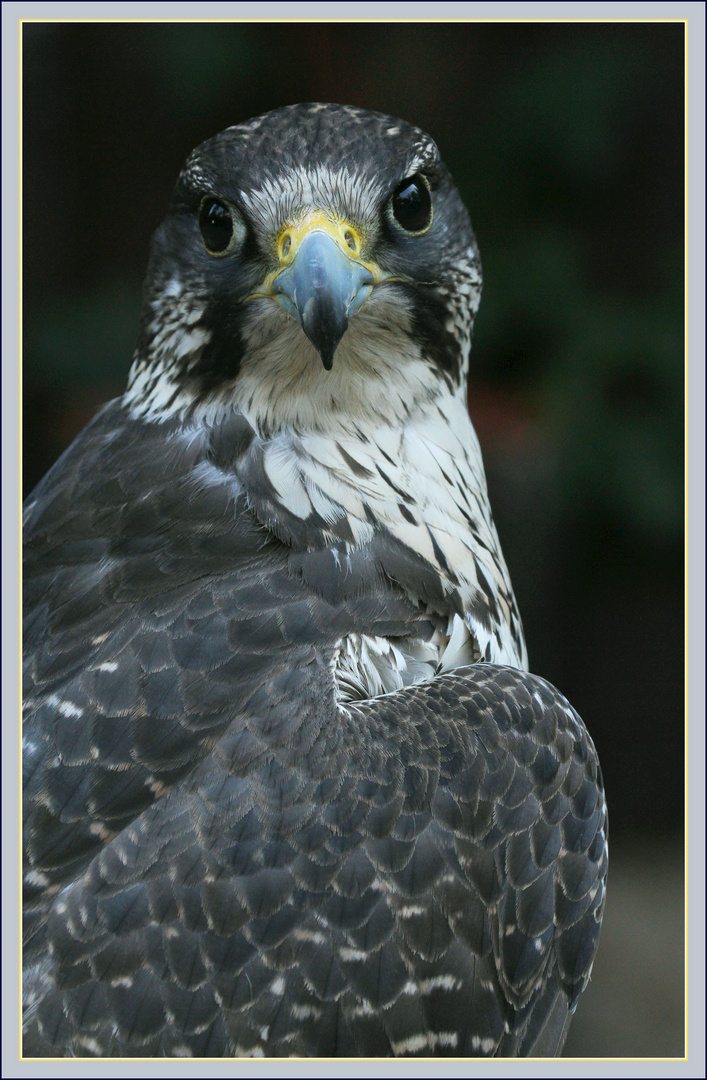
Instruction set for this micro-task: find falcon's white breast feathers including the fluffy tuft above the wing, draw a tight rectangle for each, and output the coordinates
[256,394,527,700]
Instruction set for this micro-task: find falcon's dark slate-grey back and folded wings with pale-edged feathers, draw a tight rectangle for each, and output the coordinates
[24,403,607,1056]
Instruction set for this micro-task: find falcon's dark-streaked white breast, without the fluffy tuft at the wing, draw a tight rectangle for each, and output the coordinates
[251,388,527,667]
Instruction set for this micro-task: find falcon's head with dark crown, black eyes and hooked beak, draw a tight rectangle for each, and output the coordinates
[126,105,480,430]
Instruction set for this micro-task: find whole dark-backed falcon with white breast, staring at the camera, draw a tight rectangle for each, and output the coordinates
[24,105,608,1057]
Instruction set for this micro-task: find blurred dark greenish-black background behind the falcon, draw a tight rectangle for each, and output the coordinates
[23,23,684,1057]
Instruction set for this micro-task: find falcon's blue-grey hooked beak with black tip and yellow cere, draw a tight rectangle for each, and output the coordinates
[256,214,385,372]
